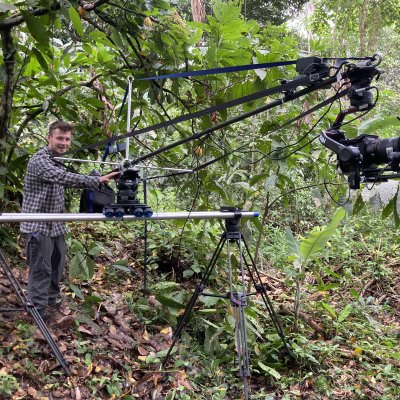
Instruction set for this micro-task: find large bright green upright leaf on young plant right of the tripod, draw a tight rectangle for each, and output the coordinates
[300,208,346,263]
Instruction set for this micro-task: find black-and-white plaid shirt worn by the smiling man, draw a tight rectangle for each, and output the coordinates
[21,146,99,237]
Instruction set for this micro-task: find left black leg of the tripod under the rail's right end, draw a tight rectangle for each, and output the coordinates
[162,235,226,368]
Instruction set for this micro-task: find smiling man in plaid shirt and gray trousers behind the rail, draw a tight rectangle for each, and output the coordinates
[21,121,119,318]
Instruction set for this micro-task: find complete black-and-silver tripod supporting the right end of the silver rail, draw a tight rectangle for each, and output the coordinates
[162,207,292,400]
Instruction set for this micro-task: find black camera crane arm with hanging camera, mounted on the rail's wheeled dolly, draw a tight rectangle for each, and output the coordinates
[57,54,400,209]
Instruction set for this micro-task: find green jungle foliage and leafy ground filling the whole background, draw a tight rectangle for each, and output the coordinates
[0,0,400,400]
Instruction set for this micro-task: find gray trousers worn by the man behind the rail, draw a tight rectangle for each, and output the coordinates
[26,232,66,309]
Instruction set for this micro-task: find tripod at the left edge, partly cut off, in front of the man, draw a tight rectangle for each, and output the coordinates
[0,248,71,376]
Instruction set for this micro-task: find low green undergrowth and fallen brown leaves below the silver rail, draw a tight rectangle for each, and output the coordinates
[0,194,400,400]
